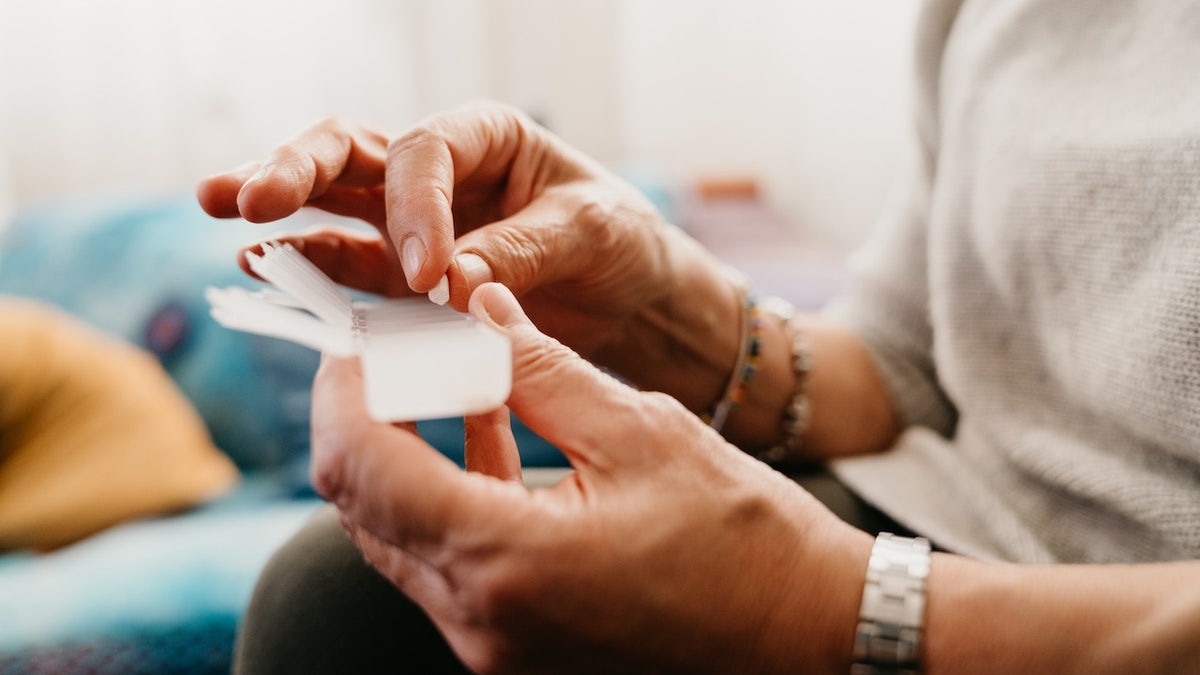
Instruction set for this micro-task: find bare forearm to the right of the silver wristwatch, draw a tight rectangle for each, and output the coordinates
[924,555,1200,675]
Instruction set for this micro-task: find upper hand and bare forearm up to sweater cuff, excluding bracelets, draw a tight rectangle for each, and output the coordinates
[198,104,895,456]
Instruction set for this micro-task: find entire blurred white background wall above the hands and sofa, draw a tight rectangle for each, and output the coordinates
[0,0,917,245]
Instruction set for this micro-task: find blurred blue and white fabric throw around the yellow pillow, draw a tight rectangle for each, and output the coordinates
[0,195,565,674]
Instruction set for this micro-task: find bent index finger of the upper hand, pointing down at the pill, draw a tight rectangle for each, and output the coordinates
[386,106,552,292]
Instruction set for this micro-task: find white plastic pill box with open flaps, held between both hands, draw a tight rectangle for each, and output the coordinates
[205,244,512,422]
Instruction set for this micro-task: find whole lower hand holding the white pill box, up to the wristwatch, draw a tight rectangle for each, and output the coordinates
[313,283,871,673]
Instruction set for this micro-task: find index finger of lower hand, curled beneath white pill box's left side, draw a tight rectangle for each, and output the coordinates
[312,357,523,542]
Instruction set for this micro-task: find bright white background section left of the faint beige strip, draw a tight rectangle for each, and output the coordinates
[0,0,415,199]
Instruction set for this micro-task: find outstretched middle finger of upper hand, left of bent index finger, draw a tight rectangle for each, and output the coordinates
[225,119,388,225]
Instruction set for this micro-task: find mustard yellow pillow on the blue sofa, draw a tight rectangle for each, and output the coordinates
[0,298,238,550]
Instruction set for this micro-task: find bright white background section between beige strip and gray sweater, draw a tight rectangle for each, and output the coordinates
[618,0,918,245]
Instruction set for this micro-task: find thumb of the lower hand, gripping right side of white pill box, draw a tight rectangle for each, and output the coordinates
[470,283,662,473]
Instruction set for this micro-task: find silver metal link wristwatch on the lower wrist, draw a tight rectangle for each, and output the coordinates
[850,532,930,675]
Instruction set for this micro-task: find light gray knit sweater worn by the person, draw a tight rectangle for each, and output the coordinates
[829,0,1200,562]
